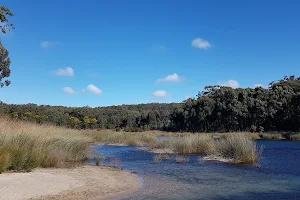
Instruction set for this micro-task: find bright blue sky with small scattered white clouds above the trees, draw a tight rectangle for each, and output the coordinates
[0,0,300,107]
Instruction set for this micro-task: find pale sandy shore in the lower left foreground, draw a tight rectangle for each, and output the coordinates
[0,166,139,200]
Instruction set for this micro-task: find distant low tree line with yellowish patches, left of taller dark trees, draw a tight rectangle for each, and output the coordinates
[0,103,180,131]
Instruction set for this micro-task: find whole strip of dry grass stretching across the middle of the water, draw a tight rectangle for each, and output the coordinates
[88,131,261,163]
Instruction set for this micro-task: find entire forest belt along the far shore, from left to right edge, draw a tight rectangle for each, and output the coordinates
[0,76,300,132]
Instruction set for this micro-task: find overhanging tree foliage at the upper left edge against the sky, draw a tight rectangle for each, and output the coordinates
[0,6,14,87]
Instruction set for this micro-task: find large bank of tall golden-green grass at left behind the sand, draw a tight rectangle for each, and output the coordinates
[0,118,92,173]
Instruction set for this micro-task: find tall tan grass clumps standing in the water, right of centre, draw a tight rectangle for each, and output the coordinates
[155,133,262,164]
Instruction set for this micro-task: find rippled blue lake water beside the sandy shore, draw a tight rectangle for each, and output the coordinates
[91,141,300,200]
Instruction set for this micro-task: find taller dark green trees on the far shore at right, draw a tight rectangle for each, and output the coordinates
[170,76,300,132]
